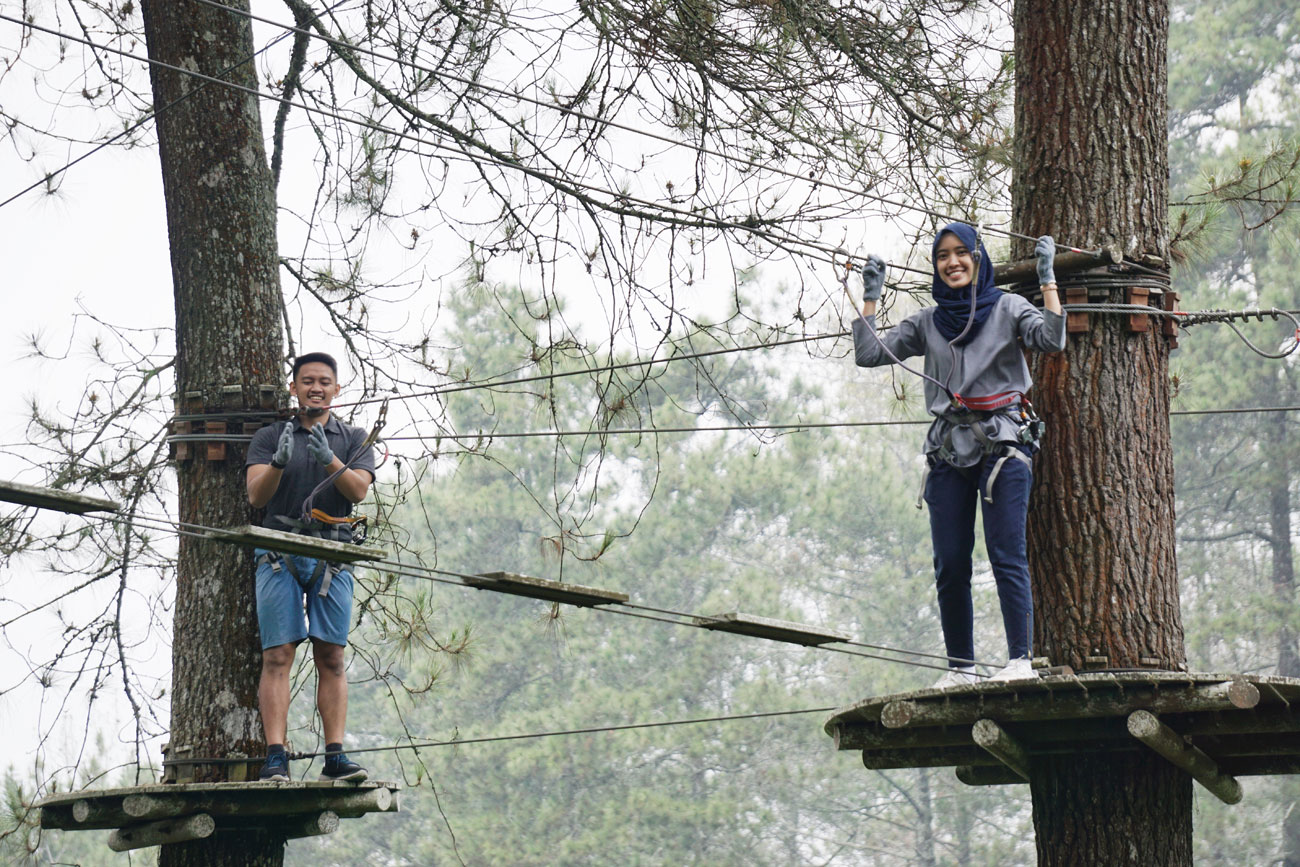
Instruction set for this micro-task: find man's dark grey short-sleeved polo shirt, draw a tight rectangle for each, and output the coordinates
[244,415,374,530]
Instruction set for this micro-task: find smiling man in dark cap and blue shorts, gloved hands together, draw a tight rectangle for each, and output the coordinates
[244,352,374,781]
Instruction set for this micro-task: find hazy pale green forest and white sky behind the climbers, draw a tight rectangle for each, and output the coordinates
[0,1,1300,864]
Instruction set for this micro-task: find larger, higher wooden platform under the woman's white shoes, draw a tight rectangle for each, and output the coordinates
[826,671,1300,803]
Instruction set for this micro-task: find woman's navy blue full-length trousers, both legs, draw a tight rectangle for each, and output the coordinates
[924,452,1034,667]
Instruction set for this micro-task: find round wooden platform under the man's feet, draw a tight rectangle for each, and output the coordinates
[36,780,400,851]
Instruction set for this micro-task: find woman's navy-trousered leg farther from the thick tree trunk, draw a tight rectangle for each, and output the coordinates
[926,461,976,668]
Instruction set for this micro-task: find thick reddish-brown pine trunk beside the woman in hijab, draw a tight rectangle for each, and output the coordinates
[1011,0,1192,867]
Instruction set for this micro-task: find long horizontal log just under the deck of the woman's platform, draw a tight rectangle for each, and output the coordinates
[880,681,1260,728]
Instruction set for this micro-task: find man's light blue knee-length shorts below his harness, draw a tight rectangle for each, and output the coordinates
[254,549,352,650]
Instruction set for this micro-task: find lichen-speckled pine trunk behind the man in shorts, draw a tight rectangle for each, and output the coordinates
[142,0,285,866]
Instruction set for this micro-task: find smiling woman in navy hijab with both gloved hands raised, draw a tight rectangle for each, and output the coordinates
[853,222,1065,689]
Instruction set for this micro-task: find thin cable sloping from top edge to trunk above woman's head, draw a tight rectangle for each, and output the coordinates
[191,0,1076,254]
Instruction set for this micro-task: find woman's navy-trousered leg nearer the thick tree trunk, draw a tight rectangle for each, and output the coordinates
[980,454,1034,659]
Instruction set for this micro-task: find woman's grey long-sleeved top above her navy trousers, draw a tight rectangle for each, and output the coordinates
[853,294,1065,467]
